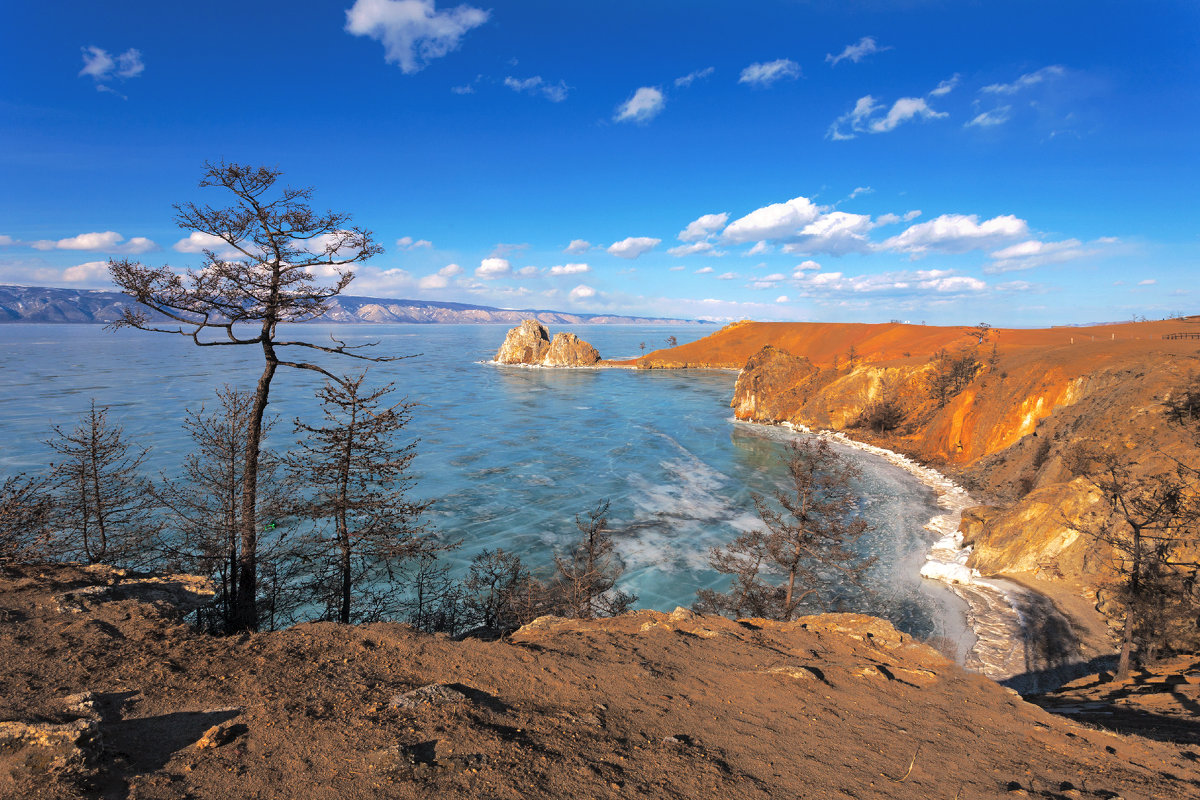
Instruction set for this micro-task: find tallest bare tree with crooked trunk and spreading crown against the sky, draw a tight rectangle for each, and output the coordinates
[108,162,392,630]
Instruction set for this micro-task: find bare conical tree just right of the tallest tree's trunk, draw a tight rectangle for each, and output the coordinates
[287,373,446,622]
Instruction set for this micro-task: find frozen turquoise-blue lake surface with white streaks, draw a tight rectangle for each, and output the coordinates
[0,324,971,643]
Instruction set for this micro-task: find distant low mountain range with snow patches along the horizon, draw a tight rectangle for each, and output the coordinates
[0,284,702,325]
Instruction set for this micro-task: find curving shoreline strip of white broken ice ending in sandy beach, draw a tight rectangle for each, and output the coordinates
[739,422,1092,692]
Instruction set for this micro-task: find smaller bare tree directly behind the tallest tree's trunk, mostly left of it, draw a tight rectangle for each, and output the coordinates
[155,385,290,632]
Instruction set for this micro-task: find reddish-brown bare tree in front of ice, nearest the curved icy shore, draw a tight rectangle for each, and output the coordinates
[696,439,875,620]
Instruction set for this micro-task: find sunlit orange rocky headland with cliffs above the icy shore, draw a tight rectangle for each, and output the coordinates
[686,321,1200,594]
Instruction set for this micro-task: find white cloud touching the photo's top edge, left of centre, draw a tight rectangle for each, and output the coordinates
[346,0,490,74]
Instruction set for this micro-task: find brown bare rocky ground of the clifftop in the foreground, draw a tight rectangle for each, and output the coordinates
[0,565,1200,800]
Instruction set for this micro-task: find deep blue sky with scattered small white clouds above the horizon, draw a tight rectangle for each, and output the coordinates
[0,0,1200,325]
